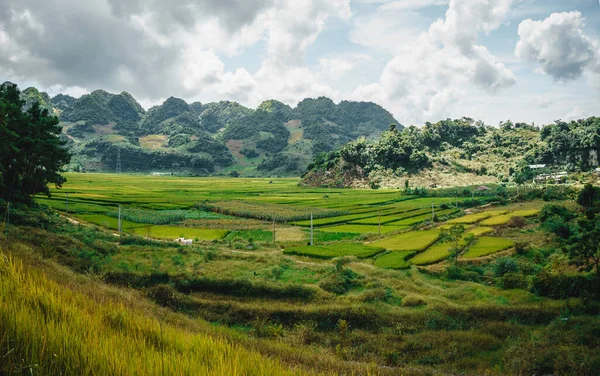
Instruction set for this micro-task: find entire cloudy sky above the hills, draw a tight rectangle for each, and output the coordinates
[0,0,600,125]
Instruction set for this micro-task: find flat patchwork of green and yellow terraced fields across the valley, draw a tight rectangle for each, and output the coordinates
[39,174,537,268]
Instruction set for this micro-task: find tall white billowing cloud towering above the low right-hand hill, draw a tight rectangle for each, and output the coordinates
[354,0,516,124]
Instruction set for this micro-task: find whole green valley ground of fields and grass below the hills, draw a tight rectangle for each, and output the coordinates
[0,174,600,375]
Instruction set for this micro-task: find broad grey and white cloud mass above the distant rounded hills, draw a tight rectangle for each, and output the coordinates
[0,0,358,107]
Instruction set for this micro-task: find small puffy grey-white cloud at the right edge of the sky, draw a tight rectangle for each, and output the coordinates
[515,12,600,81]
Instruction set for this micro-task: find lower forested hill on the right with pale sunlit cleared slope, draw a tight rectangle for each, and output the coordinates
[302,117,600,188]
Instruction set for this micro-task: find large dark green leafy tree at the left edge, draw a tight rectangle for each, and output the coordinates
[0,84,71,203]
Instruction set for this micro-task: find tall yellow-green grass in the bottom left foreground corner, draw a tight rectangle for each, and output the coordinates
[0,251,310,375]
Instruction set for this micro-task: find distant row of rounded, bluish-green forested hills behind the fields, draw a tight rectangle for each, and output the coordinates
[11,83,402,176]
